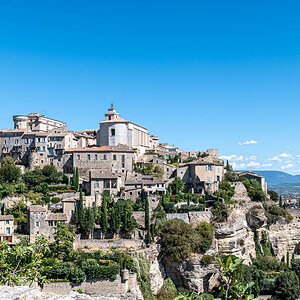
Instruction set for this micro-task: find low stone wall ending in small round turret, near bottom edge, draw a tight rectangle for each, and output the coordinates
[43,270,137,300]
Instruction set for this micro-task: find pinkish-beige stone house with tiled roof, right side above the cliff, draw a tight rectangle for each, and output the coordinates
[177,156,224,193]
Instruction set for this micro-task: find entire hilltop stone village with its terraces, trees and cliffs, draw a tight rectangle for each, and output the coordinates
[0,105,300,300]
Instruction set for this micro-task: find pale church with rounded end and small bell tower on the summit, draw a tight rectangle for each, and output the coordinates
[97,105,150,153]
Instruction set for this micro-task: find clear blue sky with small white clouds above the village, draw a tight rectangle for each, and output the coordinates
[0,0,300,174]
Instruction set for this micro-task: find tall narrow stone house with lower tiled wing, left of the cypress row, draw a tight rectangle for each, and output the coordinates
[29,205,68,243]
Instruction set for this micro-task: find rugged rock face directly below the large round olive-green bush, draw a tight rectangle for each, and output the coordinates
[164,255,219,293]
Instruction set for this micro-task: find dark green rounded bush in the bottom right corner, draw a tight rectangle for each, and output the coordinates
[276,271,300,300]
